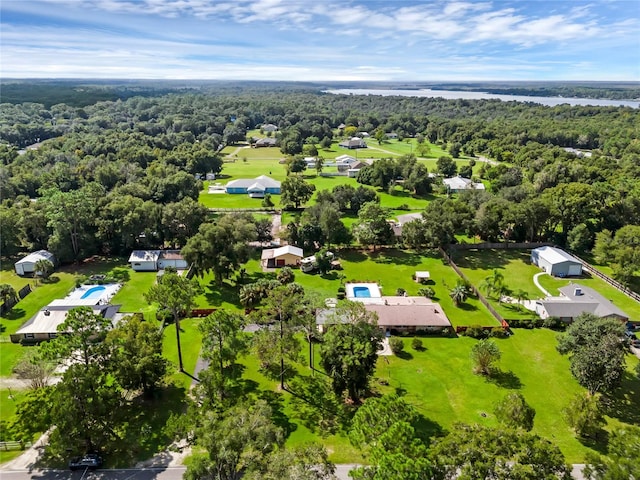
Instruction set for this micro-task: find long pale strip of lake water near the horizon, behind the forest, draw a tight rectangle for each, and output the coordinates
[325,88,640,108]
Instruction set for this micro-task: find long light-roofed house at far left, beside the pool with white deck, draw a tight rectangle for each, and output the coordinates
[10,299,120,345]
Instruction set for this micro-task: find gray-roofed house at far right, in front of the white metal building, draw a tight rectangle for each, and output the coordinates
[536,283,629,322]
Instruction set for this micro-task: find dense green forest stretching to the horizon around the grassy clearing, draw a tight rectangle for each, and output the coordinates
[0,83,640,281]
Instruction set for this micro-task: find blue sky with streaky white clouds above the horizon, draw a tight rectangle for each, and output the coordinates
[0,0,640,81]
